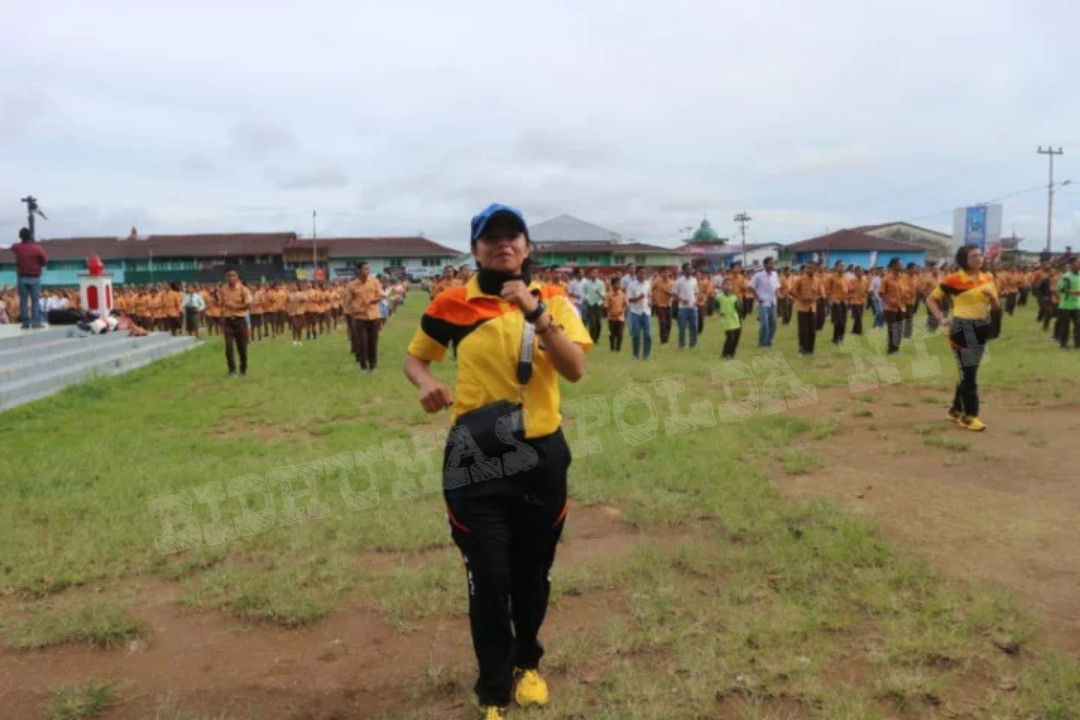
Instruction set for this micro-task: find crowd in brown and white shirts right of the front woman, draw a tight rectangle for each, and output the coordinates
[412,258,1080,359]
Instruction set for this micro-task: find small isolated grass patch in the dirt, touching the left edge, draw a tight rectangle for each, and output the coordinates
[5,602,147,650]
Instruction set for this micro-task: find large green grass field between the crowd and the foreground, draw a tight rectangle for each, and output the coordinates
[0,298,1080,720]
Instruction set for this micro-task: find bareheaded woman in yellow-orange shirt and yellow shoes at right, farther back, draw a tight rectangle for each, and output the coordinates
[927,245,1001,432]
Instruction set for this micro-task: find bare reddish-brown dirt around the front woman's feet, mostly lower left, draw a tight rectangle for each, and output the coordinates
[0,506,672,720]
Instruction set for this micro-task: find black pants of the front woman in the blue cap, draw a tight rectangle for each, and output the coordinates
[444,430,570,707]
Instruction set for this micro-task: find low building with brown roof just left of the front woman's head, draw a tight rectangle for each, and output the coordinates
[284,236,461,280]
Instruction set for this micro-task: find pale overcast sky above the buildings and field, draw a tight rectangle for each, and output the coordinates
[0,0,1080,249]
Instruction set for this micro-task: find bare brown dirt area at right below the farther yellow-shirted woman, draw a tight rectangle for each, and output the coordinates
[778,389,1080,652]
